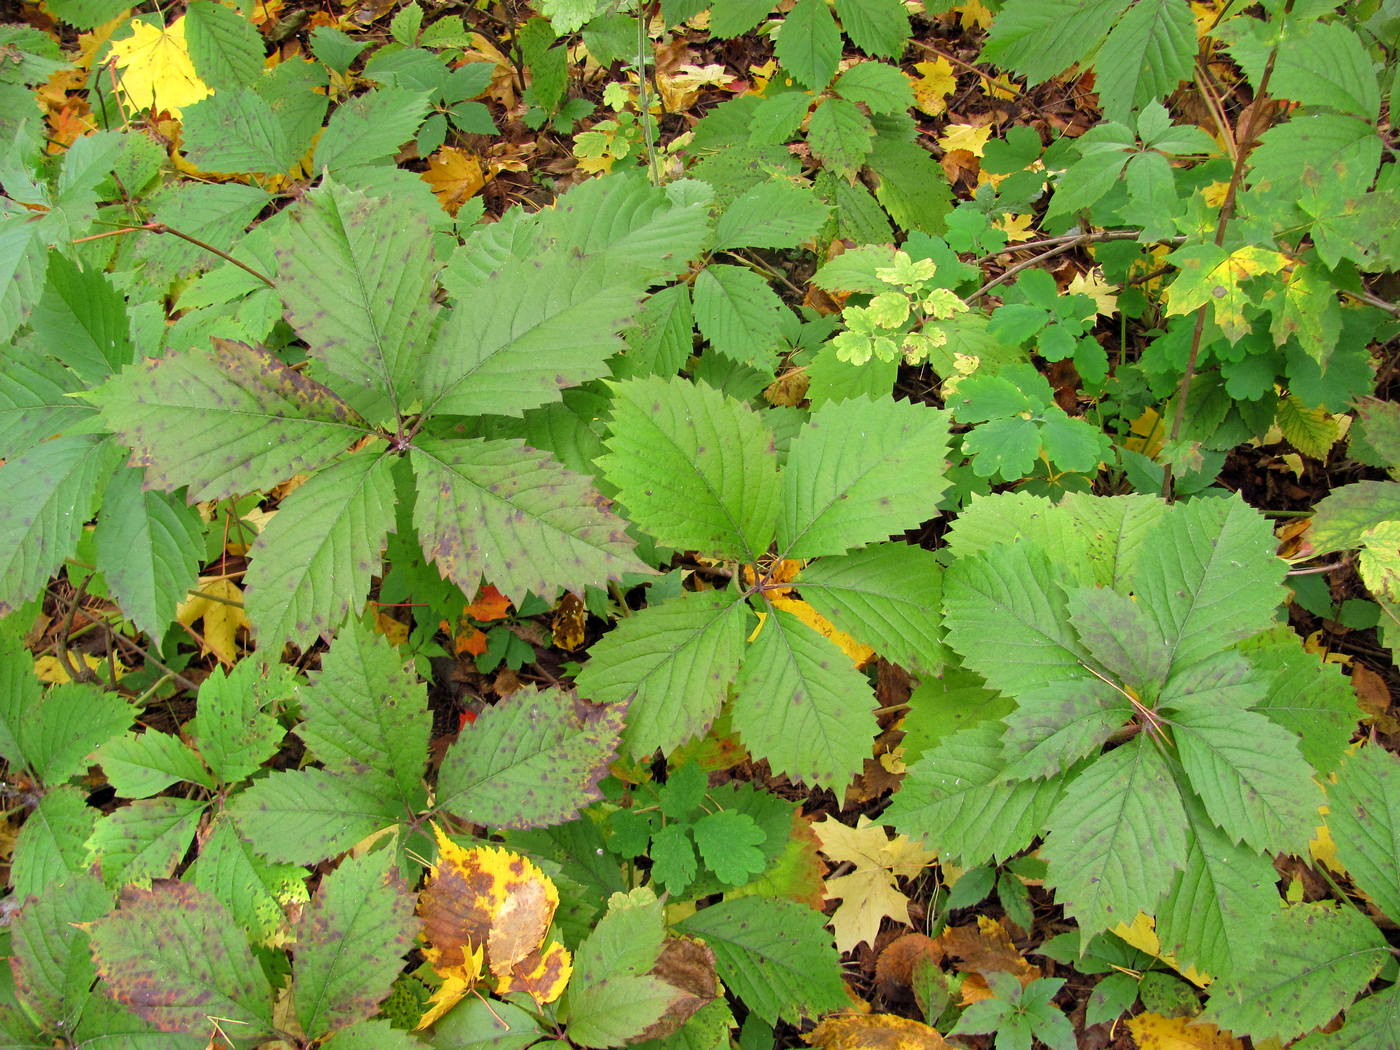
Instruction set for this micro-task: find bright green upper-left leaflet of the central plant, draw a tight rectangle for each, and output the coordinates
[598,377,778,561]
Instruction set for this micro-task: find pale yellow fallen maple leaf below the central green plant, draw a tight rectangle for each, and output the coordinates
[812,816,935,952]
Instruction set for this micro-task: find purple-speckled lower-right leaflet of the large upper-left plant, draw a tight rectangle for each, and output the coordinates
[409,438,651,601]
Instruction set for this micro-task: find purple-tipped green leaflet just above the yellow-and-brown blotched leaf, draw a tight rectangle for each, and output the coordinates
[438,687,626,827]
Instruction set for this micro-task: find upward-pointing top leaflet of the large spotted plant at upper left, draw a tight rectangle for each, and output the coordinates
[276,179,438,413]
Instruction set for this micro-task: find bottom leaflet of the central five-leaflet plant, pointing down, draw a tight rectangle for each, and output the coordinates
[732,609,876,791]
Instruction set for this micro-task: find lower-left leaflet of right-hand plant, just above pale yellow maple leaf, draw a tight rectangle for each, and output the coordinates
[882,721,1063,867]
